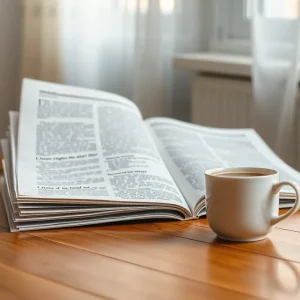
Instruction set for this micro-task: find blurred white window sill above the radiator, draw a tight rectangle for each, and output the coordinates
[174,52,252,77]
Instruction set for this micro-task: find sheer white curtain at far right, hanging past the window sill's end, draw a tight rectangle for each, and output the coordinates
[252,0,300,165]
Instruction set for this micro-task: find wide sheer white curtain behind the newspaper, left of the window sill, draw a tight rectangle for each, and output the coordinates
[59,0,200,119]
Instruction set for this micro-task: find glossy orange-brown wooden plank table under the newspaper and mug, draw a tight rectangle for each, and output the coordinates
[0,206,300,300]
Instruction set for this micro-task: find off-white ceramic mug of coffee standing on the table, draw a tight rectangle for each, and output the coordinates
[205,168,300,242]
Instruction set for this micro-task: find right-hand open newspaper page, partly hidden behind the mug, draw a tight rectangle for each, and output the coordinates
[146,118,300,211]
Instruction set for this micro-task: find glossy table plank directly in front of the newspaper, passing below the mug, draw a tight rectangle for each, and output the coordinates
[28,222,300,299]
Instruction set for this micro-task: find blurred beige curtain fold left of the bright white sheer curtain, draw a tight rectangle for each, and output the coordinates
[20,0,62,82]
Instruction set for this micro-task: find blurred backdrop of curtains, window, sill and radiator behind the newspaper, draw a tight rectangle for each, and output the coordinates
[0,0,300,169]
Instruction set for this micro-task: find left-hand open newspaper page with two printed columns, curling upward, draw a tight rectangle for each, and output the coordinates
[17,79,189,211]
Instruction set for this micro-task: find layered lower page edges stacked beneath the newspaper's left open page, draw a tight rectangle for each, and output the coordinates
[0,139,183,231]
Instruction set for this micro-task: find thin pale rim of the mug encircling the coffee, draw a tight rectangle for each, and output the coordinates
[204,167,279,180]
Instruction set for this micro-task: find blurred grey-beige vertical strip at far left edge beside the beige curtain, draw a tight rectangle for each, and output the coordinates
[0,0,22,137]
